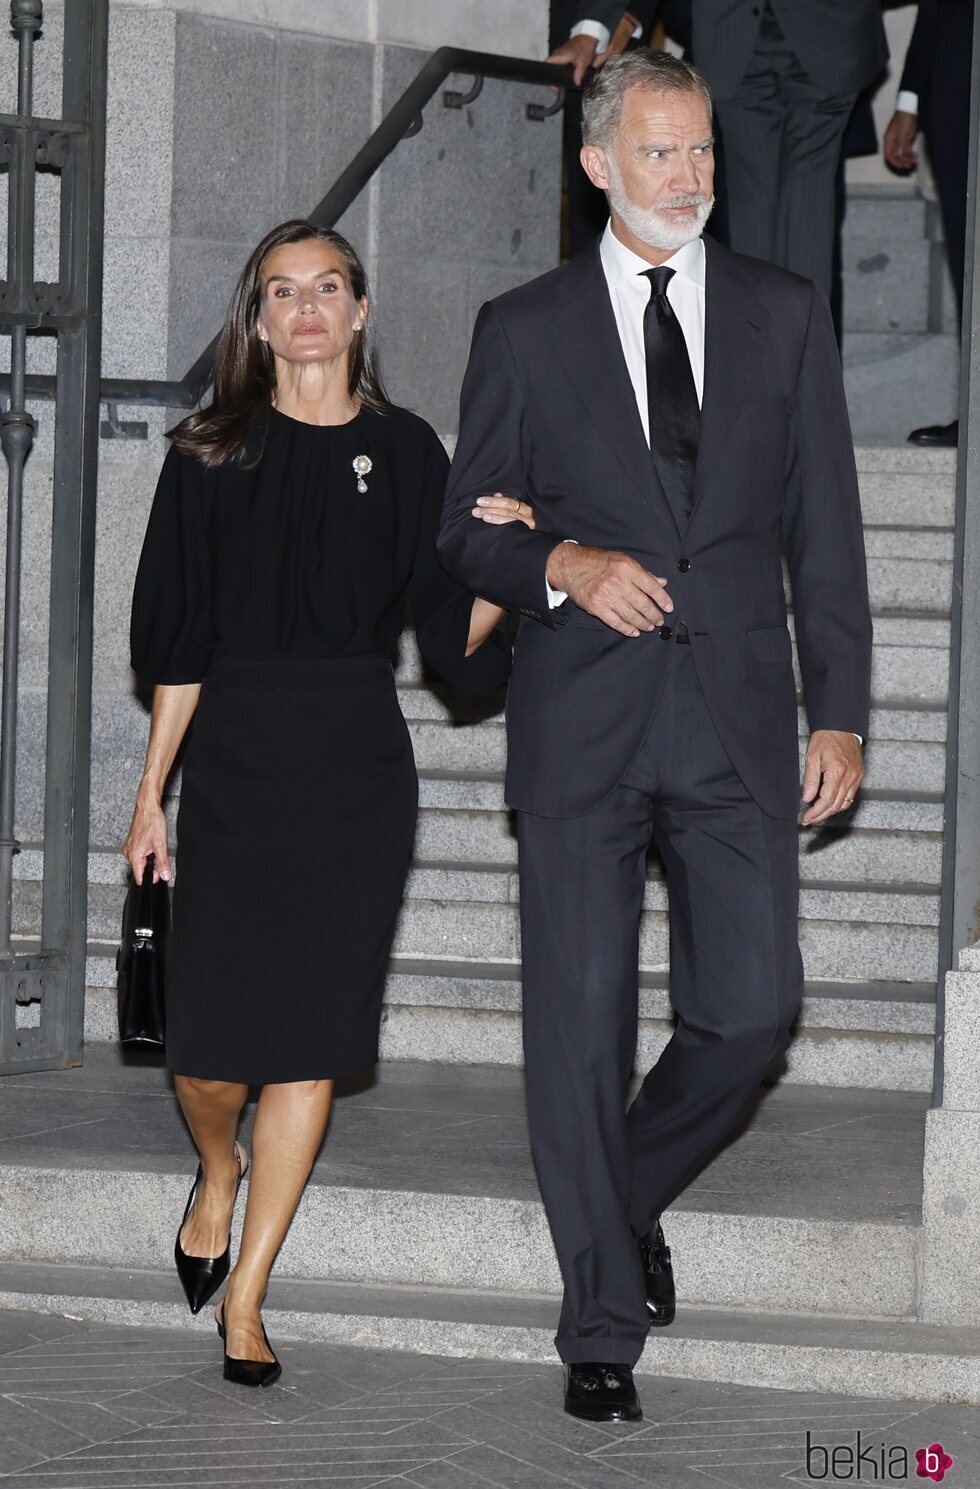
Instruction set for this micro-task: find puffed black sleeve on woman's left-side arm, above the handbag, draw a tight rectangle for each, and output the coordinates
[130,447,211,685]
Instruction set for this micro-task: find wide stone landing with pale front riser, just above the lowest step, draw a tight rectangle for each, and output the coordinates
[0,1048,926,1319]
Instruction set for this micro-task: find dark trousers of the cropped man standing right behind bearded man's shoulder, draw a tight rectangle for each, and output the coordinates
[708,9,855,295]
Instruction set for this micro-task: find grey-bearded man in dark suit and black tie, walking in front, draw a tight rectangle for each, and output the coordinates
[439,51,871,1421]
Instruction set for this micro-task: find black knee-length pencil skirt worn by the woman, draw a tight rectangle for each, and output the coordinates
[167,657,419,1085]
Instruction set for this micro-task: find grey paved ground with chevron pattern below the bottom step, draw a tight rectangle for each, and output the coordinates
[0,1313,980,1489]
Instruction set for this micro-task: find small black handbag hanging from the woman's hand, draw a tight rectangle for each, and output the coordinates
[116,853,170,1050]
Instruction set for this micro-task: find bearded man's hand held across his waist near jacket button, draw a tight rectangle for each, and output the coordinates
[547,543,673,636]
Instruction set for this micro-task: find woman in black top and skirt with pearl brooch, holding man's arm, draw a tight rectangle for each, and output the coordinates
[124,222,532,1385]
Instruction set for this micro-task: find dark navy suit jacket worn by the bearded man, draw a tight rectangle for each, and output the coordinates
[439,240,871,817]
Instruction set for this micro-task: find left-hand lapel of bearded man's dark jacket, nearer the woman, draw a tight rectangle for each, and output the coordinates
[556,244,673,521]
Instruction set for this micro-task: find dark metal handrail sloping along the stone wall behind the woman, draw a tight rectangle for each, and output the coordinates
[0,46,575,408]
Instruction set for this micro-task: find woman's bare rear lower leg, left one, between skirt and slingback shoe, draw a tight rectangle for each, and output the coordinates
[174,1075,249,1257]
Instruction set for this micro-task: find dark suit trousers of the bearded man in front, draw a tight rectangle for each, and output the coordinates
[518,643,803,1364]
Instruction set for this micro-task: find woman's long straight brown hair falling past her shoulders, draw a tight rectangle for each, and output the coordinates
[170,217,395,466]
